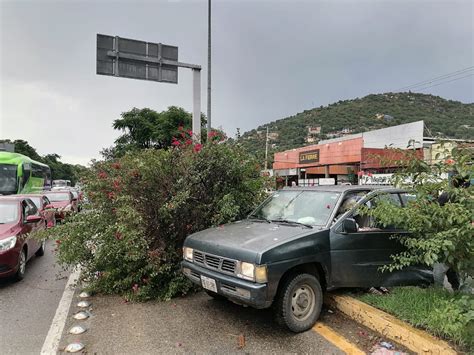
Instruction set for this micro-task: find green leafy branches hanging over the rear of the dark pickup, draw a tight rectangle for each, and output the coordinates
[362,147,474,275]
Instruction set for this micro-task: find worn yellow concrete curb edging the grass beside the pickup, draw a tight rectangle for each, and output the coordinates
[324,294,457,355]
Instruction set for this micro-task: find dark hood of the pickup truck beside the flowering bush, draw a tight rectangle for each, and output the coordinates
[184,220,310,262]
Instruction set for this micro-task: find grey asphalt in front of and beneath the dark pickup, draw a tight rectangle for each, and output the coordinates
[59,290,344,355]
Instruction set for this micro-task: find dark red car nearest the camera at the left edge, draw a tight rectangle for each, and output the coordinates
[0,197,45,280]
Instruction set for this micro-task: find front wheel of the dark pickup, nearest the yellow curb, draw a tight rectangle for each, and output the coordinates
[274,274,323,333]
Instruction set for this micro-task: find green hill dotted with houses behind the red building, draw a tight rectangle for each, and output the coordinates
[239,92,474,161]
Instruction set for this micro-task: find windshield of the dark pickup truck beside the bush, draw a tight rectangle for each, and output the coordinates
[249,190,340,226]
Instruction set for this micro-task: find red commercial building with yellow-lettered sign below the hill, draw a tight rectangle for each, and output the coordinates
[273,121,468,186]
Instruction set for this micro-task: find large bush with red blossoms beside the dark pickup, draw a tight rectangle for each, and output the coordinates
[40,142,264,300]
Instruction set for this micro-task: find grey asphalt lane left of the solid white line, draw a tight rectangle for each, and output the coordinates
[0,242,69,355]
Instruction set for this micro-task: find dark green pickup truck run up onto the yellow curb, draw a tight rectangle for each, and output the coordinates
[182,185,433,332]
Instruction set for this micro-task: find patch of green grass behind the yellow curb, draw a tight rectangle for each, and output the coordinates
[356,287,474,353]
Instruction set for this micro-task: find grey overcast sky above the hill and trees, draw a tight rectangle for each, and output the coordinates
[0,0,474,164]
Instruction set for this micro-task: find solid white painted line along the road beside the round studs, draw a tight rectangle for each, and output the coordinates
[41,269,81,355]
